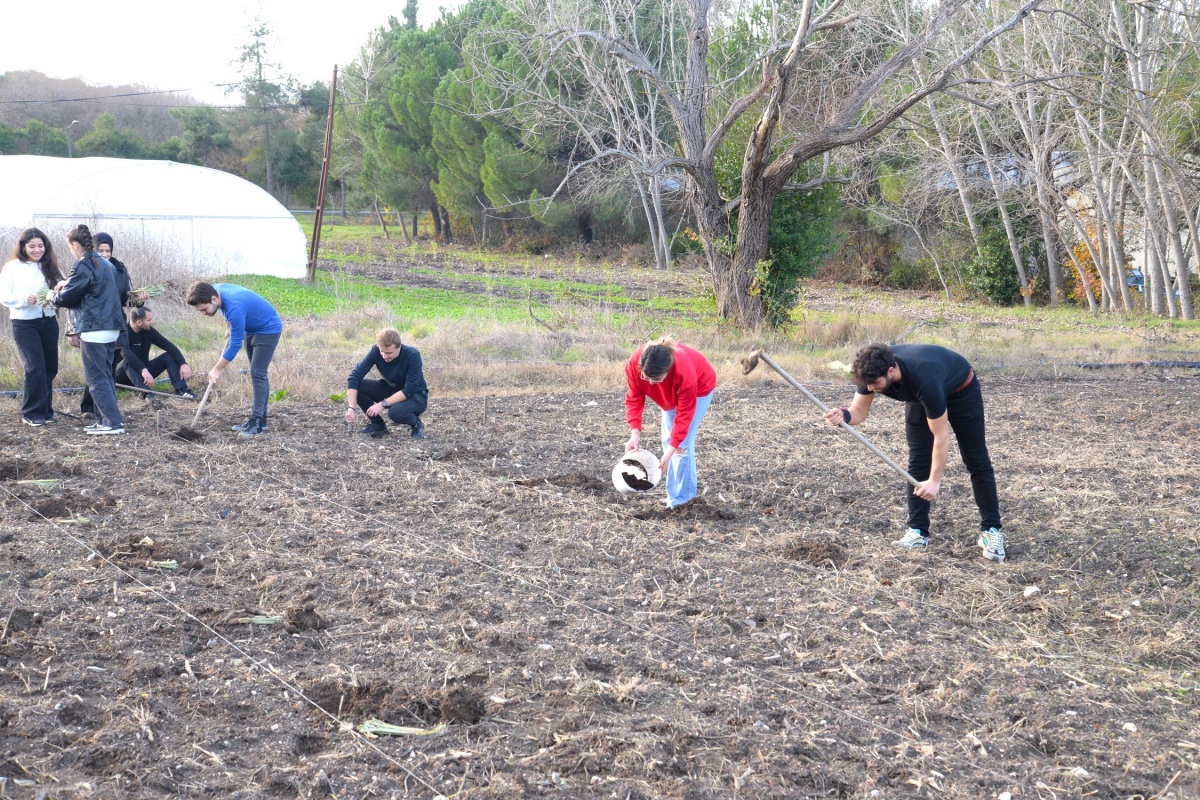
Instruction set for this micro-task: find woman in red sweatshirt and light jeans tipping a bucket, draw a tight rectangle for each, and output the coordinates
[625,337,716,509]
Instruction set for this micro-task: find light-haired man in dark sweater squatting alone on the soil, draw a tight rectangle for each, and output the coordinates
[346,327,430,439]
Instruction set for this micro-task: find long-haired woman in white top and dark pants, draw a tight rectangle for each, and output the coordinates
[0,228,62,427]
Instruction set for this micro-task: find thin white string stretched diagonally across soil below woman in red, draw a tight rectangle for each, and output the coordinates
[166,431,1032,782]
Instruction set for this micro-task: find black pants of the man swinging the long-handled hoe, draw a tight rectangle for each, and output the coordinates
[905,378,1000,536]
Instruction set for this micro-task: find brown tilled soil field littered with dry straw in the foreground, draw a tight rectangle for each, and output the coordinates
[0,375,1200,800]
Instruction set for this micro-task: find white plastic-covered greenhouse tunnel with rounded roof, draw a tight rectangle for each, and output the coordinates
[0,156,307,278]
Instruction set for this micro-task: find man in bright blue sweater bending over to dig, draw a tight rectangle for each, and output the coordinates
[187,281,283,438]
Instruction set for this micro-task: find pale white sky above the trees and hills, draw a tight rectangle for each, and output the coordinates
[0,0,458,104]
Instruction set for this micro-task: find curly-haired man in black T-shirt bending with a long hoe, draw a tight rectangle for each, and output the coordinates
[826,344,1004,561]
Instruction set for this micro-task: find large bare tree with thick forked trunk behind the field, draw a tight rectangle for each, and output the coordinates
[464,0,1039,327]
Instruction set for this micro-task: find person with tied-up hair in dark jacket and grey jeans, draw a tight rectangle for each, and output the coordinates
[49,225,125,435]
